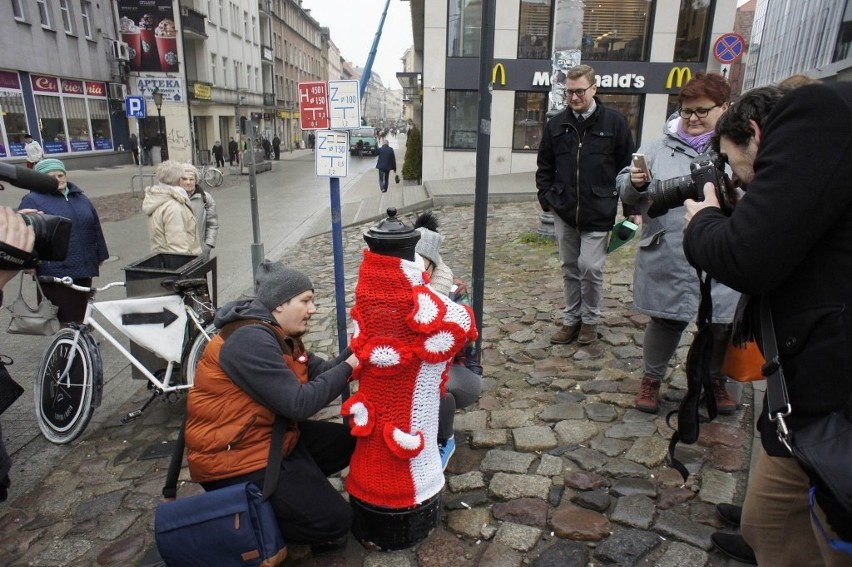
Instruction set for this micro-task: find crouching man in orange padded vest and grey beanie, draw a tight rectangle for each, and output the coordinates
[186,260,358,547]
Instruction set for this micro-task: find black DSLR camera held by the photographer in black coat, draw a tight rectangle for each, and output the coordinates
[645,150,734,218]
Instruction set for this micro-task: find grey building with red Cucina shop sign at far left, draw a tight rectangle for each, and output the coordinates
[0,0,128,167]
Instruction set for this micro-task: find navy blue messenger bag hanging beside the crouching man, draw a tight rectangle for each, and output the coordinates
[154,417,287,567]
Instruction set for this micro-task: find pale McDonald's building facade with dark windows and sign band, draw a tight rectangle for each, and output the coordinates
[403,0,736,180]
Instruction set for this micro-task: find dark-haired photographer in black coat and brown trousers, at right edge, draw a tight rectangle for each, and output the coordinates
[684,82,852,567]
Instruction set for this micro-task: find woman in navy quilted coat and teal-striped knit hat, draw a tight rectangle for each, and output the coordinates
[18,159,109,325]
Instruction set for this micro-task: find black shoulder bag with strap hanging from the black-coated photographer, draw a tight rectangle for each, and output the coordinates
[760,297,852,554]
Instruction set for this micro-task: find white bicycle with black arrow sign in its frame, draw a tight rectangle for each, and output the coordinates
[33,277,216,444]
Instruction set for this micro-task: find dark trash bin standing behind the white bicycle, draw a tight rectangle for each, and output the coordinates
[123,252,217,380]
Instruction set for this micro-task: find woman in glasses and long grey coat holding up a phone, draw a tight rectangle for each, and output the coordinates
[616,73,739,414]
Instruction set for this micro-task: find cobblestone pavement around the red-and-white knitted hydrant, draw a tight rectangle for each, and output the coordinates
[0,202,752,567]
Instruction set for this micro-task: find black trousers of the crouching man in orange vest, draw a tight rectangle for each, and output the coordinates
[202,421,355,544]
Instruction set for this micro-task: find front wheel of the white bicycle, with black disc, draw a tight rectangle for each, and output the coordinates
[33,329,100,444]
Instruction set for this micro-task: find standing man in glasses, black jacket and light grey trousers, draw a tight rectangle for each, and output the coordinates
[535,65,633,345]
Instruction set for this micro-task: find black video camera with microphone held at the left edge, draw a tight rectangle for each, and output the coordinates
[0,162,71,269]
